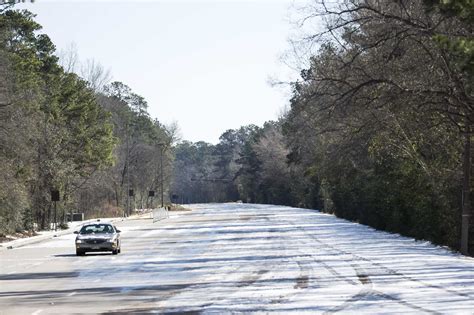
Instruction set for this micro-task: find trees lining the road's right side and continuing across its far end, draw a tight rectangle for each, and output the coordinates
[173,0,474,253]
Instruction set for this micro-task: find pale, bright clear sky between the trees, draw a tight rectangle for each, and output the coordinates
[15,0,308,144]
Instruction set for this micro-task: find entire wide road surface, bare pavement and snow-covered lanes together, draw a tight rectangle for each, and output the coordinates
[0,204,474,315]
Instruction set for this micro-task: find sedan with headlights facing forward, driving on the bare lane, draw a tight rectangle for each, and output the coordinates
[74,222,121,256]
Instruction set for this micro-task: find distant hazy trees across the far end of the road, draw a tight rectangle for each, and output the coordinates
[171,121,312,208]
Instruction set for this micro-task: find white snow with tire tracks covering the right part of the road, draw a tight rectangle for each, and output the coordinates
[143,204,474,314]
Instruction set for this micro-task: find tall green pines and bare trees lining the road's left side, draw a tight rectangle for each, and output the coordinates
[0,8,173,233]
